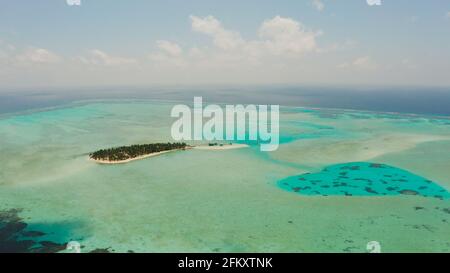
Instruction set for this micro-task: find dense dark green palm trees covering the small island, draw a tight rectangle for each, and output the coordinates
[89,142,188,162]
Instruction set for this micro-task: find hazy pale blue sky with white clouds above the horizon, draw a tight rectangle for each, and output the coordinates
[0,0,450,89]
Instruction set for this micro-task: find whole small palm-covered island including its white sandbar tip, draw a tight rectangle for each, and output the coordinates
[89,142,248,164]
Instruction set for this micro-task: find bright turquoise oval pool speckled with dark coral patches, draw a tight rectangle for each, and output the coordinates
[278,162,450,199]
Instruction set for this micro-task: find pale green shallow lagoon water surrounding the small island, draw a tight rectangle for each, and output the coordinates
[0,100,450,252]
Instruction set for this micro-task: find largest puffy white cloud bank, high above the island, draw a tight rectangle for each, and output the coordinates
[149,15,320,69]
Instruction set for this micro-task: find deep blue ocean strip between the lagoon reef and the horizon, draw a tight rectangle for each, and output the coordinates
[0,86,450,116]
